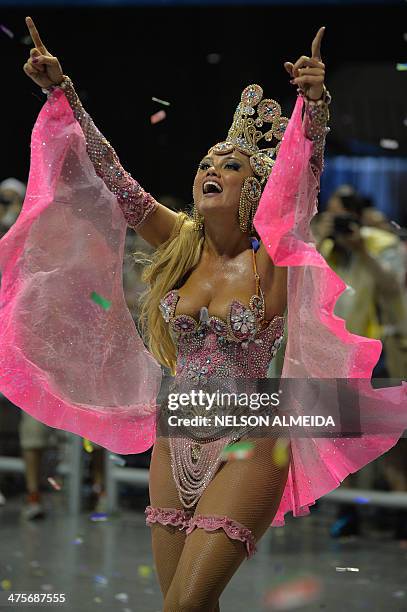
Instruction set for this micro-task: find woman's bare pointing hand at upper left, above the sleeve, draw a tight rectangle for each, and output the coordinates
[23,17,64,89]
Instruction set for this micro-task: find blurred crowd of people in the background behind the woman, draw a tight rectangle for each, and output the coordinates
[0,178,407,539]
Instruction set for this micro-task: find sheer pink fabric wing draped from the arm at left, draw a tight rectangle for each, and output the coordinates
[0,91,161,453]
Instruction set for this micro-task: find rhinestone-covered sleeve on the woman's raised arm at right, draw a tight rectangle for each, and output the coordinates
[303,86,331,180]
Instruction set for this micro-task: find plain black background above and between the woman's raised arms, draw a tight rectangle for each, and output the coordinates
[0,2,407,222]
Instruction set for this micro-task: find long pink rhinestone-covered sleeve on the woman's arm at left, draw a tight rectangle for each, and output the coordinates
[43,76,158,229]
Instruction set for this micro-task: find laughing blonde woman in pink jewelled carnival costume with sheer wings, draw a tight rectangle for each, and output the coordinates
[0,18,407,612]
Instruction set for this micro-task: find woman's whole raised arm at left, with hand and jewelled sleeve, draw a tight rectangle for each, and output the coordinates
[24,17,177,247]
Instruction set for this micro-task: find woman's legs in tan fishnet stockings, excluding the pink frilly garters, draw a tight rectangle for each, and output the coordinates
[150,438,288,612]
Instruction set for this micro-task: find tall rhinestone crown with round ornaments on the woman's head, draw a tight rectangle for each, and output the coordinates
[210,85,288,183]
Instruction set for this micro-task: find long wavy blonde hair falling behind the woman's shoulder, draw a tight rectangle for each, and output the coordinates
[132,212,204,375]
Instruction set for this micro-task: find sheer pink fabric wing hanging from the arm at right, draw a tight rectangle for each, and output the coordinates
[254,97,407,526]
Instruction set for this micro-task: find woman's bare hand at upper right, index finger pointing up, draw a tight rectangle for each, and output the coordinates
[284,27,325,100]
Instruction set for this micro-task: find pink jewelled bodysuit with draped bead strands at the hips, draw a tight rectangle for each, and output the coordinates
[160,249,284,508]
